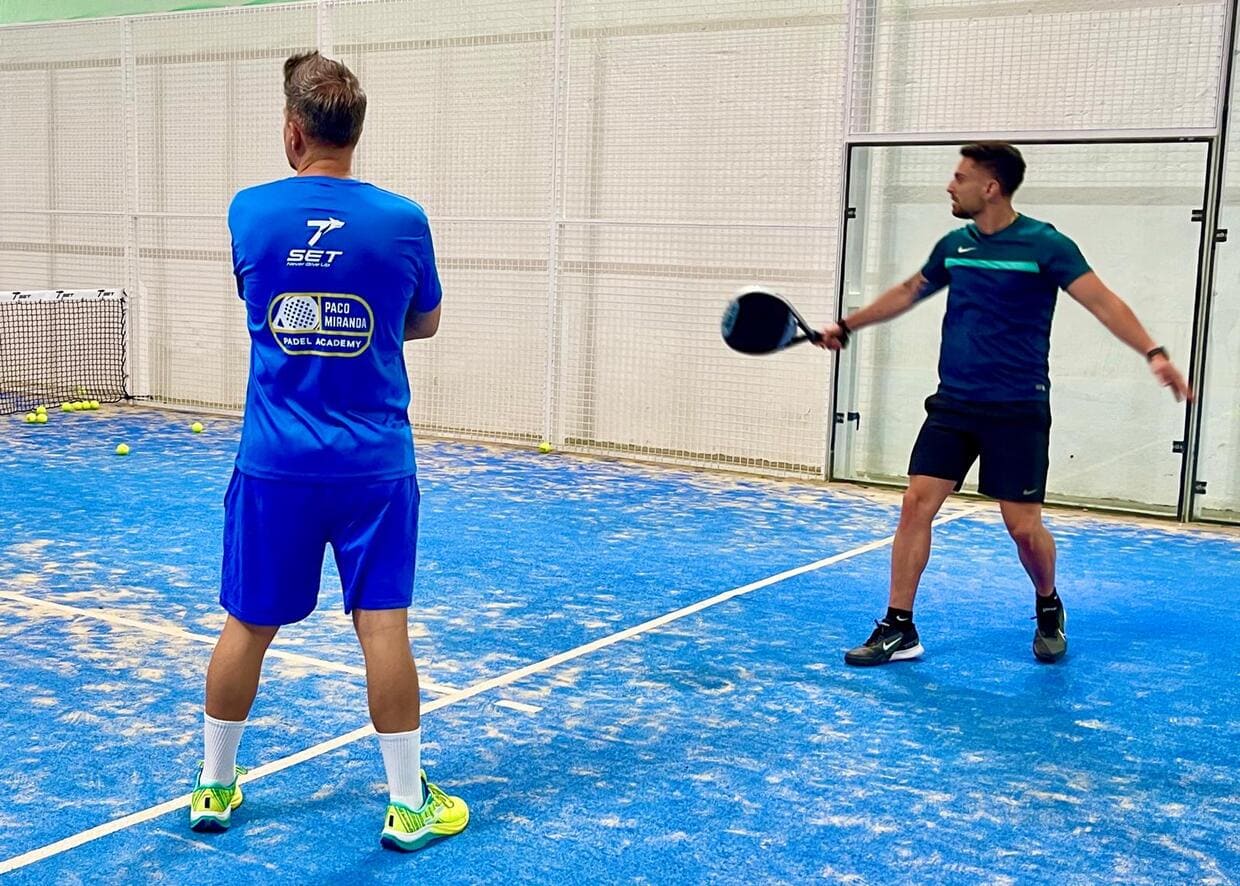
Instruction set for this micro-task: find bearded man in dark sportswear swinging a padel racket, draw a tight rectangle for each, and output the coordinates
[822,143,1192,665]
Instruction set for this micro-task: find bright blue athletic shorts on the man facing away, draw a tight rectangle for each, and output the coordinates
[219,470,418,625]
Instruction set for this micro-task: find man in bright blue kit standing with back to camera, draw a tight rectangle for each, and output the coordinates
[190,52,469,850]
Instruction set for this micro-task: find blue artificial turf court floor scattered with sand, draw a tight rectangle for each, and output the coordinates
[0,406,1240,884]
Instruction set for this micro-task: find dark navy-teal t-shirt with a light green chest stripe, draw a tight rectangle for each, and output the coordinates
[921,216,1090,403]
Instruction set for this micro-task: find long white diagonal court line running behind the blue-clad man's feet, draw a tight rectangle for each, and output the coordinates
[0,507,982,874]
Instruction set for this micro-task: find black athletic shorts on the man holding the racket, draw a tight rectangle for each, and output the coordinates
[909,394,1050,502]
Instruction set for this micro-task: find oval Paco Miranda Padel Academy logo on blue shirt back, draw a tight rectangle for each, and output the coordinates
[267,292,374,357]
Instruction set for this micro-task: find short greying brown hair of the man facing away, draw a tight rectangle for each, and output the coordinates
[284,50,366,147]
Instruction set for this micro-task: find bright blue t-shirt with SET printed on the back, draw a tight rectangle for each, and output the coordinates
[228,176,443,481]
